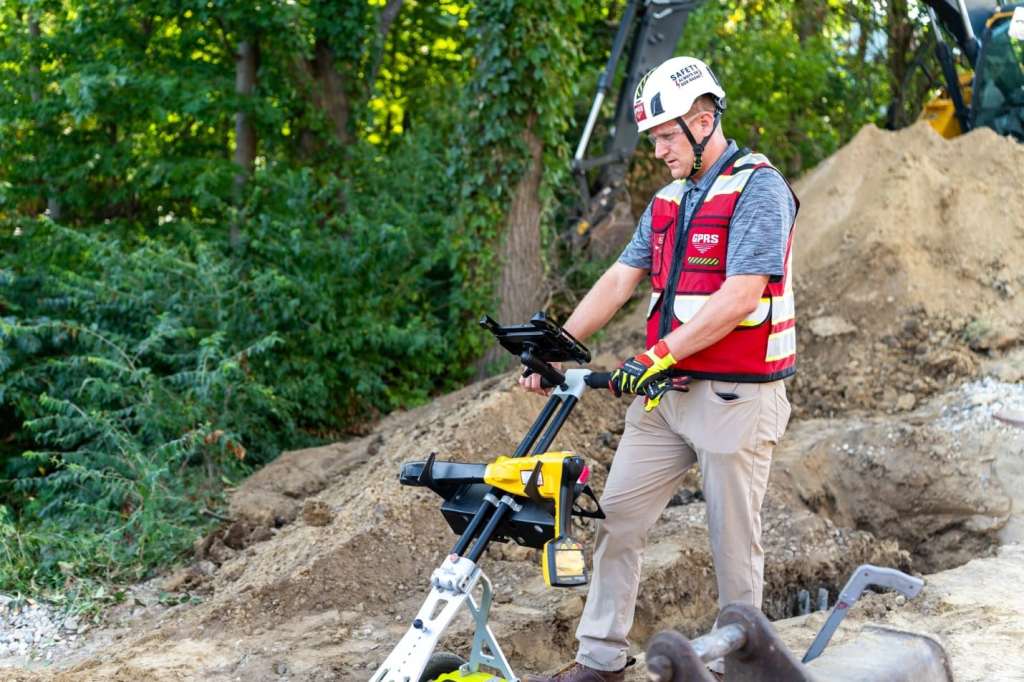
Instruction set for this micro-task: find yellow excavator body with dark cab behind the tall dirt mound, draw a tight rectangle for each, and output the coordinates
[921,0,1024,142]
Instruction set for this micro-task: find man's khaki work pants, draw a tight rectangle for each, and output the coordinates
[577,380,790,671]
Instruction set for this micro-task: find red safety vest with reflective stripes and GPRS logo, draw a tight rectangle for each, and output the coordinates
[647,150,800,382]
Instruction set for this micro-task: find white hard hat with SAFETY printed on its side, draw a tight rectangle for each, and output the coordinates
[633,57,725,132]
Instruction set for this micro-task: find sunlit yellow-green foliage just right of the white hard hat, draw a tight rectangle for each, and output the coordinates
[679,0,888,175]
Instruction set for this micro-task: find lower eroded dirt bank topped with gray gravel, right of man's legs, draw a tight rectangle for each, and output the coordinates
[772,380,1024,572]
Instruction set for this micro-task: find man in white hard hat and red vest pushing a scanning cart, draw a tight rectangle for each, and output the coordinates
[520,57,797,682]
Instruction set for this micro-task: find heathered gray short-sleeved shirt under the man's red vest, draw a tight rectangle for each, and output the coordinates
[618,140,797,281]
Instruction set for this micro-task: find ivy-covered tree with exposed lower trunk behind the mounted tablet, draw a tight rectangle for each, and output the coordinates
[453,0,583,366]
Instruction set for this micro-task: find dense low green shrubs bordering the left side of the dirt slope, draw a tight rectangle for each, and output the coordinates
[0,99,468,589]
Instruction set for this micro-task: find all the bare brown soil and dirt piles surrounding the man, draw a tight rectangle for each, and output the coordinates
[0,126,1024,682]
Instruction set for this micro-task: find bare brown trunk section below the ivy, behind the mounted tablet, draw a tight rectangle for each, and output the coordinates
[479,121,546,376]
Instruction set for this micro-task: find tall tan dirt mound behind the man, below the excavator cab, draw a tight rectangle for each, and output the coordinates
[793,124,1024,416]
